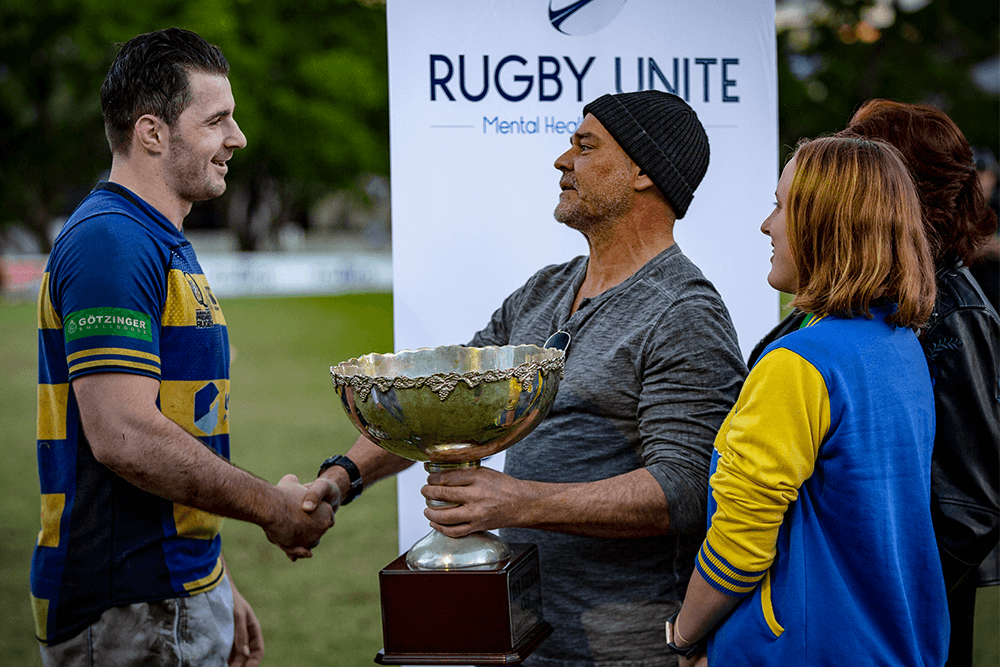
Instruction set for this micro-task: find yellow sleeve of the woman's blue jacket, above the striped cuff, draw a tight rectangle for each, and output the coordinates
[707,348,830,573]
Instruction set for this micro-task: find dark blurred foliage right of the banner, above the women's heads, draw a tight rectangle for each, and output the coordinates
[778,0,1000,162]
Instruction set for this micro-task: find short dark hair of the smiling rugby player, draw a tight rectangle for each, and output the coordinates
[101,28,229,154]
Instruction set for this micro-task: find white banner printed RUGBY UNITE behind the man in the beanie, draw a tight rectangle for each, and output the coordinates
[387,0,778,550]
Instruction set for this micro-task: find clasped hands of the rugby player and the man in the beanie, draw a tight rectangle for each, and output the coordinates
[264,475,340,561]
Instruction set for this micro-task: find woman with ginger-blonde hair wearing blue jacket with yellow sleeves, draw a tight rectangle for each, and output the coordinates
[667,137,948,667]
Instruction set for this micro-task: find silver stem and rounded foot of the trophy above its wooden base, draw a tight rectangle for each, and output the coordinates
[406,460,511,570]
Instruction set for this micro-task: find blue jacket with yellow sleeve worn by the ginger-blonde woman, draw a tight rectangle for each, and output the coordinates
[696,309,948,667]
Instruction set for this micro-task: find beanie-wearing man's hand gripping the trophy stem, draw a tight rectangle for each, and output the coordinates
[420,468,528,537]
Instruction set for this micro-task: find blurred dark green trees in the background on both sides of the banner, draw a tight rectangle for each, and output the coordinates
[0,0,1000,251]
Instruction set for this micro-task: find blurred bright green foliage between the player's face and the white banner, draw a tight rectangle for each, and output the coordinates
[218,0,389,196]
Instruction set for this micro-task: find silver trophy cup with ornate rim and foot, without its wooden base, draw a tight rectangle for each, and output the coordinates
[330,342,568,570]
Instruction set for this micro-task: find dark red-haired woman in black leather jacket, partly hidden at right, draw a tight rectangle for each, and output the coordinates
[747,99,1000,667]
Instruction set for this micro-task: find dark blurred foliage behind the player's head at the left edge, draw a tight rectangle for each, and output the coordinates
[0,0,115,245]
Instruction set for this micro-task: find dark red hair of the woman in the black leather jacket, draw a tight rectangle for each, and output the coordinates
[839,99,997,267]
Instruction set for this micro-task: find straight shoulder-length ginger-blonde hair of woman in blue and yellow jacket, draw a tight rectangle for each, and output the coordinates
[786,136,935,329]
